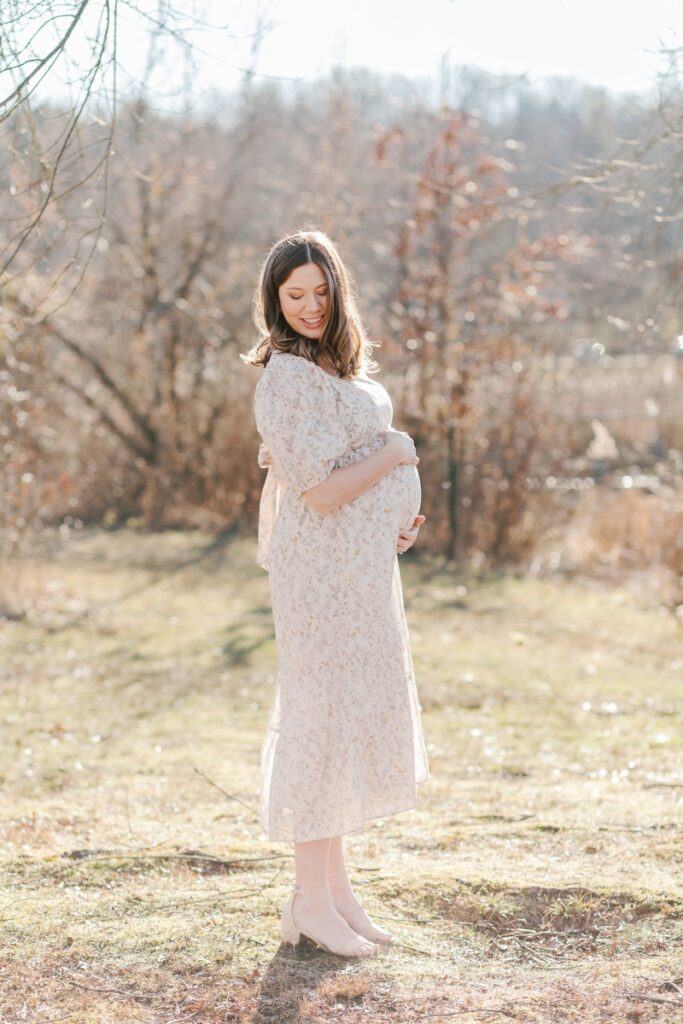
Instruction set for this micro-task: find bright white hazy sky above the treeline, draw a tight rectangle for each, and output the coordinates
[21,0,683,102]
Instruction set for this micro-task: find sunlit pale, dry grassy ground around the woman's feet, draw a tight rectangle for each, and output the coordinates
[0,530,683,1024]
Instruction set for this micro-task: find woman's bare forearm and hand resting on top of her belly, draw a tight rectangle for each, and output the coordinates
[301,431,420,515]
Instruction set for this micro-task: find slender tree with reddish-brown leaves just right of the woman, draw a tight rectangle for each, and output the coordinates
[387,108,589,559]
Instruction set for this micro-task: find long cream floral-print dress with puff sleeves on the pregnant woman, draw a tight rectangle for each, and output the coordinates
[254,352,429,842]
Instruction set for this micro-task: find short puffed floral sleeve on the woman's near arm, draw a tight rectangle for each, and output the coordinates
[254,354,349,493]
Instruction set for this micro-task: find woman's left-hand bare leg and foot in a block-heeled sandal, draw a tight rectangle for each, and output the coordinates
[282,839,377,956]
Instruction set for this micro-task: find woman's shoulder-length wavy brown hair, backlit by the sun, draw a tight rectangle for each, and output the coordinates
[241,230,379,377]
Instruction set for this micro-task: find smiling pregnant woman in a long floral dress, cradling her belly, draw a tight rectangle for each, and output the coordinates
[244,231,429,956]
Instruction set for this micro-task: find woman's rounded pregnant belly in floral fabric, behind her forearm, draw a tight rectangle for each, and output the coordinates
[335,435,422,539]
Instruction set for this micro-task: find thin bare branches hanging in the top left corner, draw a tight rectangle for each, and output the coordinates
[0,0,268,303]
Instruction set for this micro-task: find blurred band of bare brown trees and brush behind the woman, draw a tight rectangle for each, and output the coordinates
[0,0,683,613]
